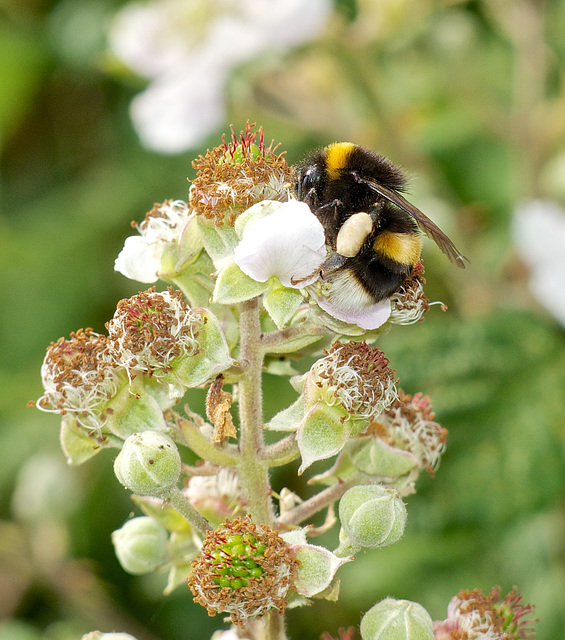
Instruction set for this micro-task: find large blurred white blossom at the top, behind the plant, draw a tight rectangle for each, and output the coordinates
[109,0,332,153]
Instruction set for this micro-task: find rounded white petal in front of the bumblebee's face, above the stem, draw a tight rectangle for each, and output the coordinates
[234,200,326,289]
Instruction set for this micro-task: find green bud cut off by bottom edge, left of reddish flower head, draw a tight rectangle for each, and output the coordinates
[361,598,434,640]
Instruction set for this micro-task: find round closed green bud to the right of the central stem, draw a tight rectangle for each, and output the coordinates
[339,484,407,549]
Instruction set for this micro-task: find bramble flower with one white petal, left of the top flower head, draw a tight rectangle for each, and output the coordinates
[114,200,194,283]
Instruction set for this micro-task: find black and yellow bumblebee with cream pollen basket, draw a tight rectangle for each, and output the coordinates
[295,142,466,309]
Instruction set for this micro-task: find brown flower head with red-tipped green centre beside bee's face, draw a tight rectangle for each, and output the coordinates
[190,122,292,226]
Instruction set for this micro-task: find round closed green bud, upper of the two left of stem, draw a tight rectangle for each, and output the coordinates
[114,431,181,497]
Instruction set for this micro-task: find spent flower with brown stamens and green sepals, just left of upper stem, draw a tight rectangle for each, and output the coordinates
[106,287,231,395]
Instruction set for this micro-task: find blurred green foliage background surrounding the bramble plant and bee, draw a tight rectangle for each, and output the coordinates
[0,0,565,640]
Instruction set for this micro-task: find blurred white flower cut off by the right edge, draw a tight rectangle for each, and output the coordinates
[513,200,565,327]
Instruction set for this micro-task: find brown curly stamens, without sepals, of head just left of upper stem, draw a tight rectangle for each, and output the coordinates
[106,287,204,377]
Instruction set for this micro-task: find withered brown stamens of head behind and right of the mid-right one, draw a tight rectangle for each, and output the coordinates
[371,389,447,475]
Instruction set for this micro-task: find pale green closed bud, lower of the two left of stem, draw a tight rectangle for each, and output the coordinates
[112,516,168,575]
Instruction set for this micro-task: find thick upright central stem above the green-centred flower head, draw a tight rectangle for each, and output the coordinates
[238,298,274,525]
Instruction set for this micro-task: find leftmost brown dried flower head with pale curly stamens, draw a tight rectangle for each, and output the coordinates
[36,328,122,432]
